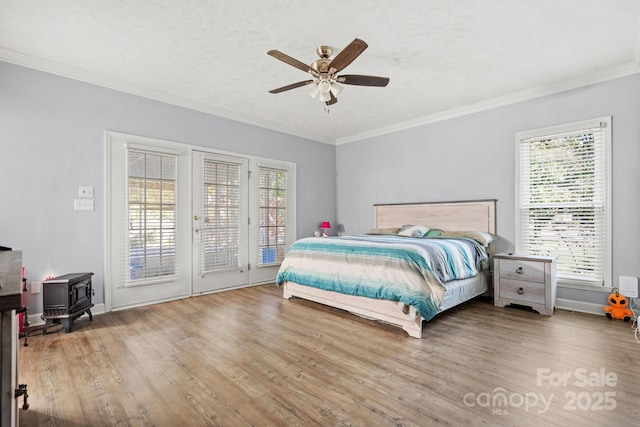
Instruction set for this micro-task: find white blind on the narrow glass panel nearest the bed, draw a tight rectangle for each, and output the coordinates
[257,166,288,265]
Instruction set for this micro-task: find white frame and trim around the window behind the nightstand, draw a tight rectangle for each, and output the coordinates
[515,116,612,290]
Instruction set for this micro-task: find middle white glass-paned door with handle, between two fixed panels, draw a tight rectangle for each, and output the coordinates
[192,151,249,294]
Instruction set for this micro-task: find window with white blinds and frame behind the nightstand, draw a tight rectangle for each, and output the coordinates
[516,117,611,286]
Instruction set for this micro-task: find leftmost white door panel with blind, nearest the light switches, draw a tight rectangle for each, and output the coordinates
[105,132,191,310]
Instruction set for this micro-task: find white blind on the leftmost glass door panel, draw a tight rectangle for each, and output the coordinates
[126,149,178,284]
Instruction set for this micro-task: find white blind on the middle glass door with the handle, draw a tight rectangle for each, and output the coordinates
[200,160,241,273]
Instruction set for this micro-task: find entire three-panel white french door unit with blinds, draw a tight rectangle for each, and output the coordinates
[105,131,296,311]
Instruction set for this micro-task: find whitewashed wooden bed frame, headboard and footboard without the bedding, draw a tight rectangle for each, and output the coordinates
[283,200,496,338]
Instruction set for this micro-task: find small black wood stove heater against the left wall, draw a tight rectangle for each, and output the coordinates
[42,273,94,335]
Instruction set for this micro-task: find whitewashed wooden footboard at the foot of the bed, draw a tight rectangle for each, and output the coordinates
[282,282,422,338]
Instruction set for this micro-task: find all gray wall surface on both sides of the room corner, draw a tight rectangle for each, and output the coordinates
[0,62,640,313]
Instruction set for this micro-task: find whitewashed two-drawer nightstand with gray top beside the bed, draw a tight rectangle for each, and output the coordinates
[493,254,556,316]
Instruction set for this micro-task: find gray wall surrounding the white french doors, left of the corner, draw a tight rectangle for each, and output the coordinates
[0,62,336,313]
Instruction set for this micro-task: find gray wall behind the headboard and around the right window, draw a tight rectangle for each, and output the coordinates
[336,74,640,304]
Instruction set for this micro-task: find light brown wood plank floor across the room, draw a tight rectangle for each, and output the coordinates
[20,285,640,427]
